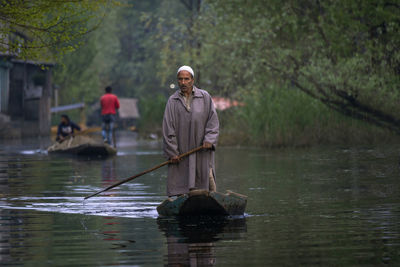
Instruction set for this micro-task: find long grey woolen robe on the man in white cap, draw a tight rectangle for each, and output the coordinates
[163,87,219,196]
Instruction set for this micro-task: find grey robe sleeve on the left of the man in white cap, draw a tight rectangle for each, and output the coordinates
[162,100,179,158]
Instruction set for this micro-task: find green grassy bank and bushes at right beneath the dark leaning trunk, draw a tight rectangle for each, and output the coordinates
[214,89,400,147]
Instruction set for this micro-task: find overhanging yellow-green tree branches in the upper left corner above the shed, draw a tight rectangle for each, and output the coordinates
[0,0,115,59]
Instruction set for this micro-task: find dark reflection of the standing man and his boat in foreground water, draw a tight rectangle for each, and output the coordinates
[157,217,246,266]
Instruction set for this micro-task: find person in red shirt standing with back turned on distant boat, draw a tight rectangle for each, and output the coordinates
[100,86,119,144]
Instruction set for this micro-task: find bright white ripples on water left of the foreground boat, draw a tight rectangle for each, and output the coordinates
[0,184,164,218]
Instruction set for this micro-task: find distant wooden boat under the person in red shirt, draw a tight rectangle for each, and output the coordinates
[47,136,117,156]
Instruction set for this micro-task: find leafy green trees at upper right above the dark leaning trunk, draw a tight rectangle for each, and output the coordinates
[200,0,400,133]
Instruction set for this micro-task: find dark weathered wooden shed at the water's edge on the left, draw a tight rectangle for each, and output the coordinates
[0,54,53,138]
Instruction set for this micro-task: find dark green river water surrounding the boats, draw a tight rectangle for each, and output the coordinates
[0,134,400,266]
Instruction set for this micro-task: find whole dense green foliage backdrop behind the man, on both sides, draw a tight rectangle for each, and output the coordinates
[46,0,400,146]
